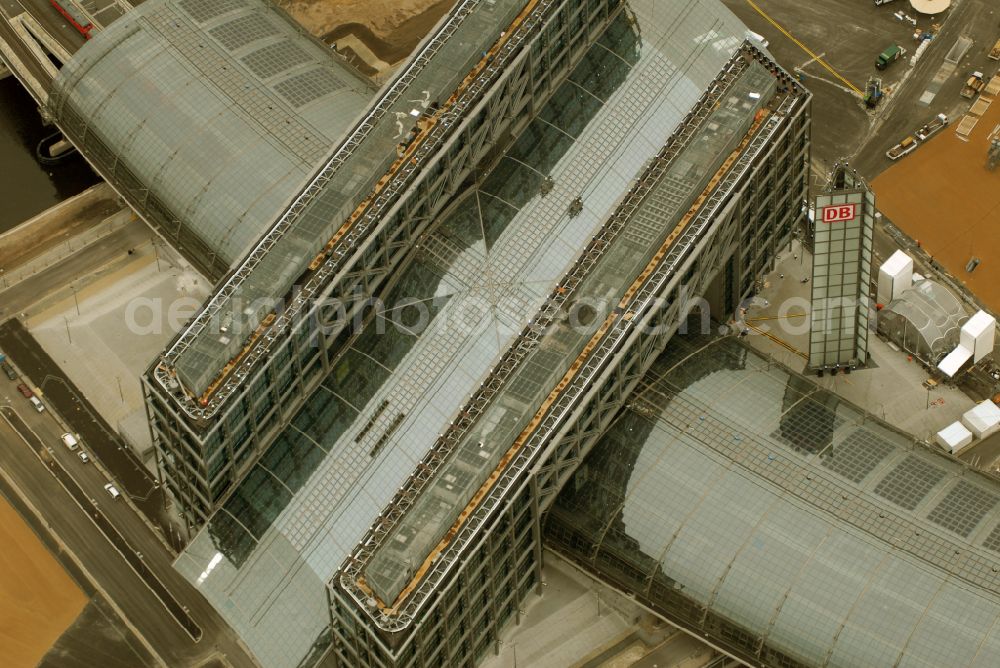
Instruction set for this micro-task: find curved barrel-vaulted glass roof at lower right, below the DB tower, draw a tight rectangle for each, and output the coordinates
[545,336,1000,668]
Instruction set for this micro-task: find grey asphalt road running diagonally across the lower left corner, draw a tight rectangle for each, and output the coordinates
[0,378,254,667]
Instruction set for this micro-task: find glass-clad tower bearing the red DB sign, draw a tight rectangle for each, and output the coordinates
[809,163,875,373]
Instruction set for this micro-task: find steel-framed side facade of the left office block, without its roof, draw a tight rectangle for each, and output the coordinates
[143,0,618,530]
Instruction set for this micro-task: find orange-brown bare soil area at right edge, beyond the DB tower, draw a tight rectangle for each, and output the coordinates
[872,99,1000,311]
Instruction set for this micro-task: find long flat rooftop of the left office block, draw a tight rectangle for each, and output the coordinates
[167,0,548,397]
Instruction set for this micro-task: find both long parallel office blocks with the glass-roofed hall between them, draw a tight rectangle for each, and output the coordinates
[158,0,809,666]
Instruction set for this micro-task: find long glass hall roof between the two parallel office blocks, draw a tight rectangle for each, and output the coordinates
[176,0,752,666]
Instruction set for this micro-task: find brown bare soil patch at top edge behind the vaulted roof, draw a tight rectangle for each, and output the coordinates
[282,0,455,64]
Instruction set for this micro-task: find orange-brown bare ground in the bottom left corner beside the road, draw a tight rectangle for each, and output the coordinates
[0,497,87,668]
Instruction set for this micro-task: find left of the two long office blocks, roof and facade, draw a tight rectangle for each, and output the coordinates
[144,0,600,525]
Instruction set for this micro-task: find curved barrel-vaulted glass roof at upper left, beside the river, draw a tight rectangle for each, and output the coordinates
[51,0,374,277]
